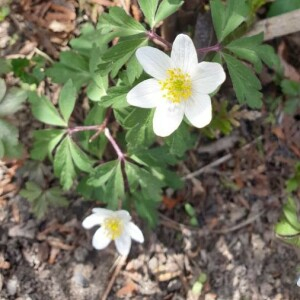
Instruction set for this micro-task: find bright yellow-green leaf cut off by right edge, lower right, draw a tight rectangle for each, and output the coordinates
[275,197,300,247]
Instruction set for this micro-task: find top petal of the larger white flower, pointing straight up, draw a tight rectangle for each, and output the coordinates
[171,34,198,73]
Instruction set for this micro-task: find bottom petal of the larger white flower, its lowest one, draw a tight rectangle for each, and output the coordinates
[153,99,184,137]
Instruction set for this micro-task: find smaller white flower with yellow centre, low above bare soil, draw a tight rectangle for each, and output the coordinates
[82,208,144,255]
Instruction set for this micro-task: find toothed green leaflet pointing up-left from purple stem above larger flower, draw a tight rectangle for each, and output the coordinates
[98,7,146,39]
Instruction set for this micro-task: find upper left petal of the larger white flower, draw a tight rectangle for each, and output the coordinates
[136,46,172,80]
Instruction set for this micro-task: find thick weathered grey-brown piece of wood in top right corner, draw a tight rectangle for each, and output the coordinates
[247,9,300,41]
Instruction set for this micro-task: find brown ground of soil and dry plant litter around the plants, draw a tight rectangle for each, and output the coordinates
[0,0,300,300]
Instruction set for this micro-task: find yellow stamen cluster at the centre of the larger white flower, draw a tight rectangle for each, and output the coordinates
[159,68,192,103]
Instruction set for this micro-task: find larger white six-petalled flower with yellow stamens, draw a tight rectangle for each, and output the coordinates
[127,34,226,137]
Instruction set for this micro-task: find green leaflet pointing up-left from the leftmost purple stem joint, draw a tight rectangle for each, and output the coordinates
[29,92,68,127]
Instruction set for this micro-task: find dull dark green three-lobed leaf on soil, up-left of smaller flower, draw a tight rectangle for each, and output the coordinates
[20,181,68,219]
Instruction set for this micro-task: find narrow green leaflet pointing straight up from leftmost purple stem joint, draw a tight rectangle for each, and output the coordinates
[58,79,76,123]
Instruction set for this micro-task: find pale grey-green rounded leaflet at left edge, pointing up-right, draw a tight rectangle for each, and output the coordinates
[0,87,27,117]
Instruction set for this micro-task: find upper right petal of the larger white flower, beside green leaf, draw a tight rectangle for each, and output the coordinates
[192,61,226,94]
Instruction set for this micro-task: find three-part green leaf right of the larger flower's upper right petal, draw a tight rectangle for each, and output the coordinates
[211,0,279,108]
